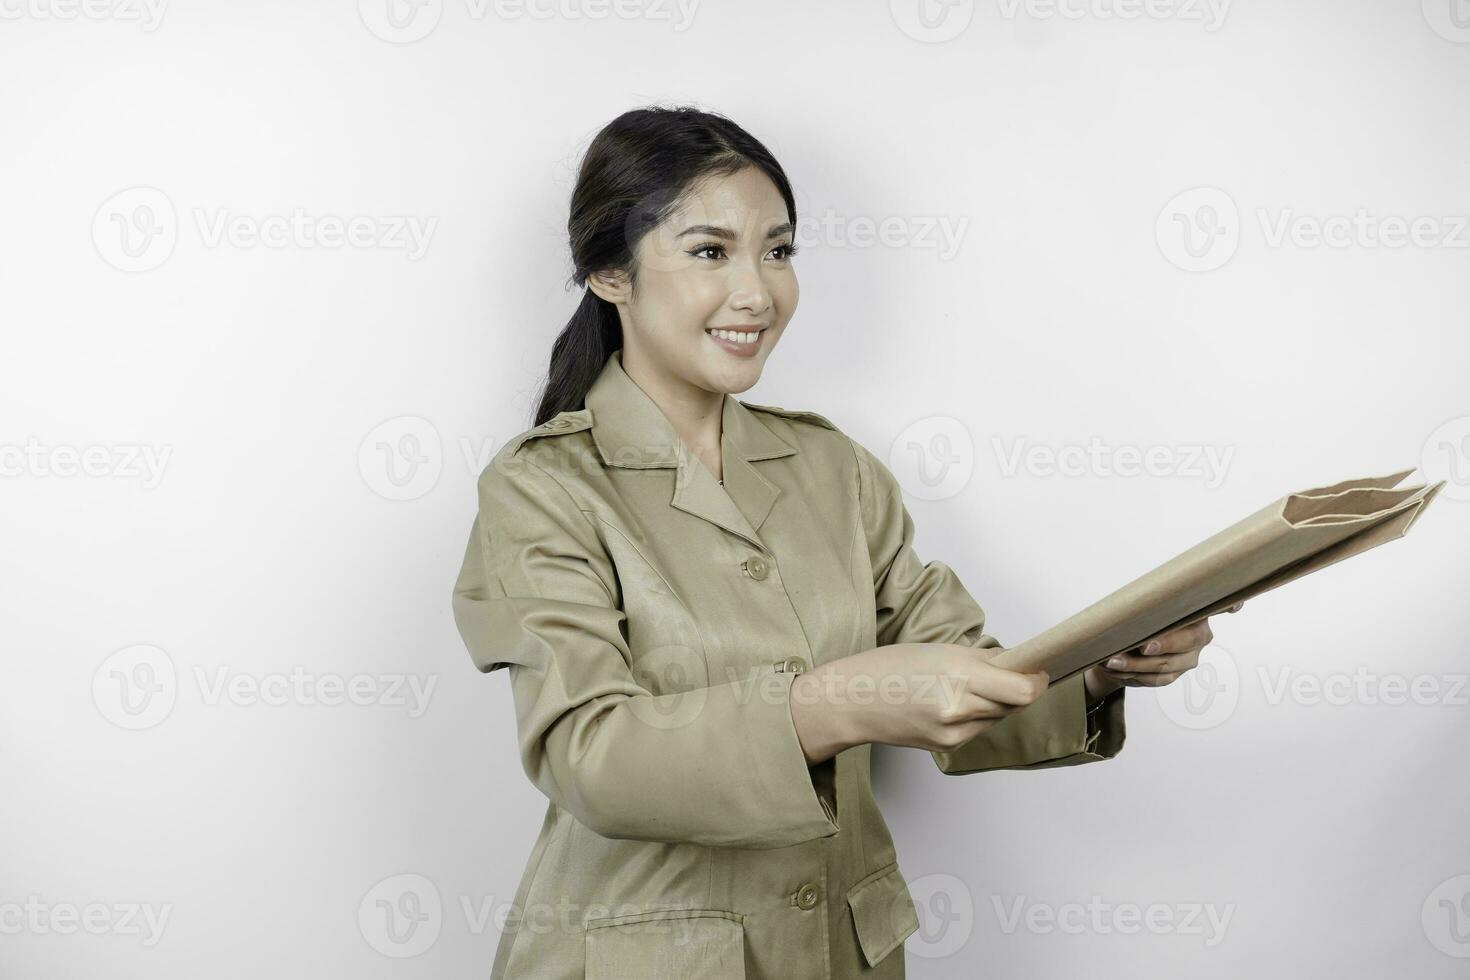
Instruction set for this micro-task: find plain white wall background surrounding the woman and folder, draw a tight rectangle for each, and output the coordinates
[0,0,1470,980]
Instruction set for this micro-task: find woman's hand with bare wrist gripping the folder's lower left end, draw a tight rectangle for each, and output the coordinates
[791,644,1050,764]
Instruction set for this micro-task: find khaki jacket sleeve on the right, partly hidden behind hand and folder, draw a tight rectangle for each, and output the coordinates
[853,441,1126,774]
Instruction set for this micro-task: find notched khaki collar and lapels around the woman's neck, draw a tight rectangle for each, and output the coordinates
[585,350,800,551]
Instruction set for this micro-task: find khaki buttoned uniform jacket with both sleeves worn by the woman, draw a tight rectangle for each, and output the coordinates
[453,351,1125,980]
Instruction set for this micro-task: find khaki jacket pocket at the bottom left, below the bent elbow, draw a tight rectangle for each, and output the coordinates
[587,908,745,980]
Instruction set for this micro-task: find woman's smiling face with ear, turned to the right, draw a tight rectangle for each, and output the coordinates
[597,166,800,394]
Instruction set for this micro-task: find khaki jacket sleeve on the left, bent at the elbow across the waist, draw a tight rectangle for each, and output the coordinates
[453,455,838,848]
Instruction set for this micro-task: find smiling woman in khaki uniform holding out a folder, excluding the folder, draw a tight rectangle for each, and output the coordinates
[454,109,1228,980]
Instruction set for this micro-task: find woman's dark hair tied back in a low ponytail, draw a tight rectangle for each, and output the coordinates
[532,106,797,425]
